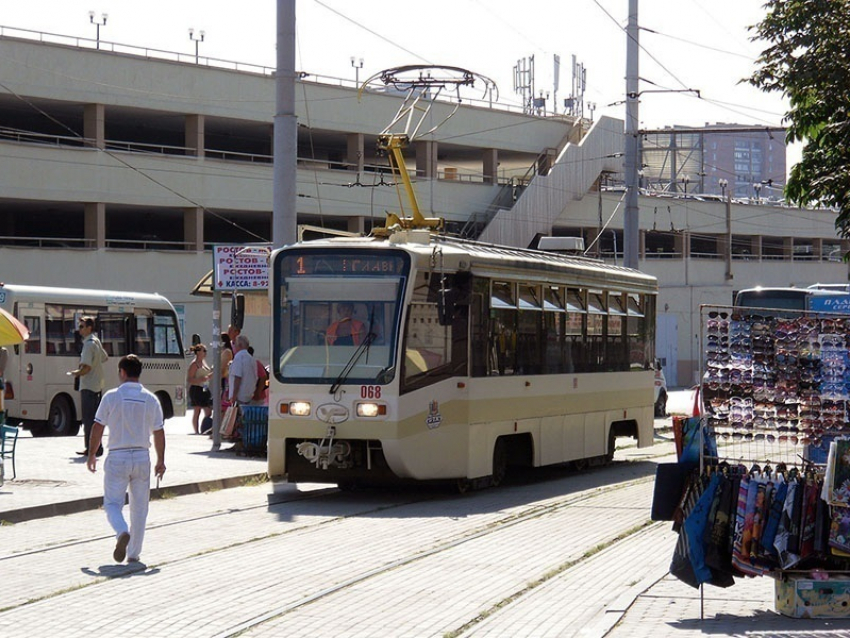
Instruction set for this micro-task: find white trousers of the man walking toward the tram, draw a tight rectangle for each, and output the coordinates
[103,449,151,558]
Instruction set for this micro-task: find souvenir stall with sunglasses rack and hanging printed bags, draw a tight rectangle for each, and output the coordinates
[670,306,850,617]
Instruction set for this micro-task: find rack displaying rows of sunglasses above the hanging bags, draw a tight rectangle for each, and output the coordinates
[701,307,850,465]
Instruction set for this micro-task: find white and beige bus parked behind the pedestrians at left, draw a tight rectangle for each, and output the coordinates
[0,284,186,436]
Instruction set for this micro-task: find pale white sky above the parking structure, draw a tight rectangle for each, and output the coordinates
[0,0,799,165]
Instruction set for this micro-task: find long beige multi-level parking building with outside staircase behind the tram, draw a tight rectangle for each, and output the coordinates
[0,30,850,385]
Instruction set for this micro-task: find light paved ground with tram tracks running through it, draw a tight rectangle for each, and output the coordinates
[0,396,850,638]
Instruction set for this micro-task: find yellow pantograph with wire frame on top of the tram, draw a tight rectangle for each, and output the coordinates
[358,64,498,236]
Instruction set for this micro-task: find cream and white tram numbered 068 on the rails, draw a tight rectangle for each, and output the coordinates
[268,229,658,490]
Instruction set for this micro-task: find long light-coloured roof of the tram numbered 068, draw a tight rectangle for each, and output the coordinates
[278,231,658,291]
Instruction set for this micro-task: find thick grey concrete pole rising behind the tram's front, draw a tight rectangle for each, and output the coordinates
[272,0,298,248]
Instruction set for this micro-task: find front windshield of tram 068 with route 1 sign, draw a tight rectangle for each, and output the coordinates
[273,250,409,386]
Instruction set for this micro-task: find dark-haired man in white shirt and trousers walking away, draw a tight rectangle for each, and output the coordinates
[87,354,165,563]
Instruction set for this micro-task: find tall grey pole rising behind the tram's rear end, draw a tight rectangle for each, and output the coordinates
[623,0,640,268]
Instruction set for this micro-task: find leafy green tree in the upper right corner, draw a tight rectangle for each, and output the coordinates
[747,0,850,238]
